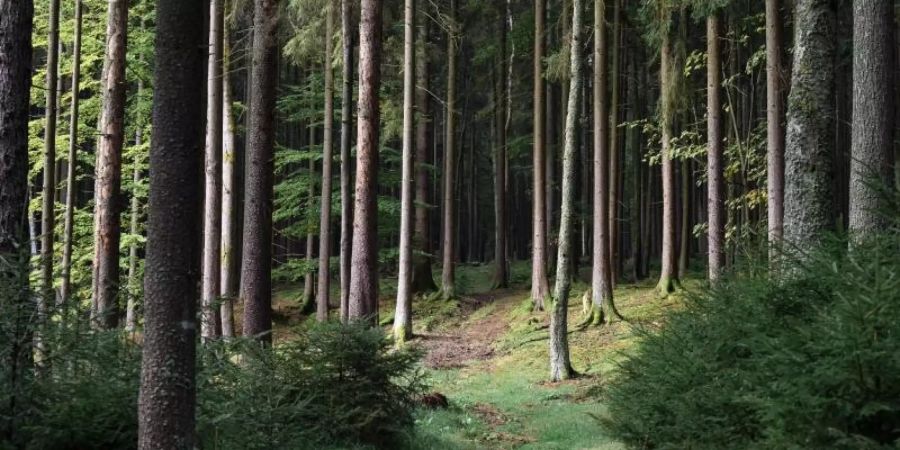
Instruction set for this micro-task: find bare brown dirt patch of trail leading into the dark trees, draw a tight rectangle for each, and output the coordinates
[419,292,523,369]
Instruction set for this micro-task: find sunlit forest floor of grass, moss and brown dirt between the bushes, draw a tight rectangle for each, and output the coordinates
[276,266,691,450]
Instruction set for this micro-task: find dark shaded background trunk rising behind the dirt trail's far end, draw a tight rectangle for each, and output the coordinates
[493,10,509,289]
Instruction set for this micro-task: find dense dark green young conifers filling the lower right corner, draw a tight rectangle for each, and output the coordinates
[605,230,900,449]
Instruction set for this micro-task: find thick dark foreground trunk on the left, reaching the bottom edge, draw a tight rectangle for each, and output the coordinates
[138,0,206,444]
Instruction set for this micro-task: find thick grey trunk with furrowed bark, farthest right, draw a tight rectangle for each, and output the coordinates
[850,0,896,239]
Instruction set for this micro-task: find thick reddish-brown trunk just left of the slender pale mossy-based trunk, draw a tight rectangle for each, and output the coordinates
[348,0,382,323]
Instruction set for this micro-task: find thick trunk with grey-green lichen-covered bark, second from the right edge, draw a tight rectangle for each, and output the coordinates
[784,0,835,252]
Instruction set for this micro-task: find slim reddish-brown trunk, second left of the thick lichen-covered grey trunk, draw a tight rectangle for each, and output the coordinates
[706,14,725,284]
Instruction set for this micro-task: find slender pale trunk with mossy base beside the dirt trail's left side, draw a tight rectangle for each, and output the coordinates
[394,0,416,345]
